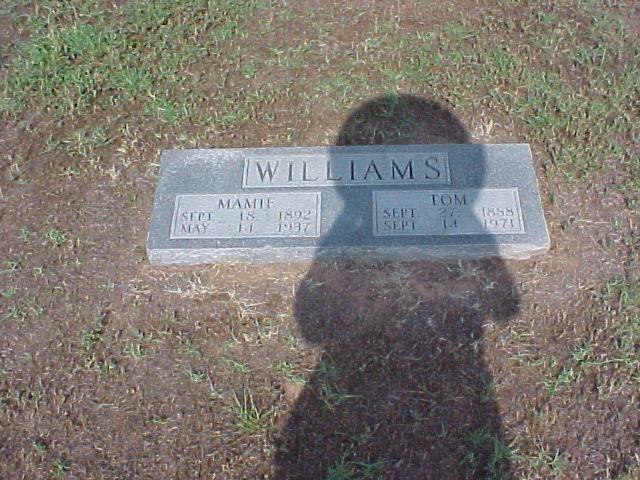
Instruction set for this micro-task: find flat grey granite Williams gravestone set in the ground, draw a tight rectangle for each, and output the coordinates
[147,144,549,265]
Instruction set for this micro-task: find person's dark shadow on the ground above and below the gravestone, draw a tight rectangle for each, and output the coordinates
[274,95,518,480]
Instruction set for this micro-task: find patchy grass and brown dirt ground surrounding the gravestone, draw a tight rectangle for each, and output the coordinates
[0,0,640,480]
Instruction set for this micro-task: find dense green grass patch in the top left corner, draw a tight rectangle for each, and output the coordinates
[0,0,264,122]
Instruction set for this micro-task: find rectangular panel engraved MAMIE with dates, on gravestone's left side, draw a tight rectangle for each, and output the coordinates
[171,192,320,239]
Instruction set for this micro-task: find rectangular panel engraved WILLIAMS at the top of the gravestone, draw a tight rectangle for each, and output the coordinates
[244,152,450,187]
